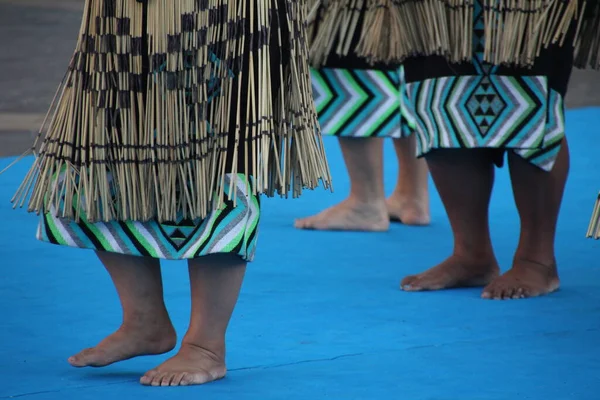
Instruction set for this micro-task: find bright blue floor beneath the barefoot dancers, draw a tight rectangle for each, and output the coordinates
[0,109,600,400]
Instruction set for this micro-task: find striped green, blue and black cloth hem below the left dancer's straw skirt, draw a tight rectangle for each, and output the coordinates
[37,174,260,261]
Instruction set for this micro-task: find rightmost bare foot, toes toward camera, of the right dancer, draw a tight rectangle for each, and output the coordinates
[481,259,560,300]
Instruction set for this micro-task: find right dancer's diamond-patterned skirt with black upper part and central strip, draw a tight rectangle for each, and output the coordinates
[402,0,575,171]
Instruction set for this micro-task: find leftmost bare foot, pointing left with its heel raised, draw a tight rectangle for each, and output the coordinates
[68,321,177,368]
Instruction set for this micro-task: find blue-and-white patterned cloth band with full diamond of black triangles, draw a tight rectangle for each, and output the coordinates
[406,75,565,171]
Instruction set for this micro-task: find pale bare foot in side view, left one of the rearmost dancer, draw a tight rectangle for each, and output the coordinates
[294,199,390,232]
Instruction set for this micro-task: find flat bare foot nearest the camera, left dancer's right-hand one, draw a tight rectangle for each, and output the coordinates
[140,343,227,386]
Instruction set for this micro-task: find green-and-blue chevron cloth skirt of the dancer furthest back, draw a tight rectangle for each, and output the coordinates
[309,0,411,138]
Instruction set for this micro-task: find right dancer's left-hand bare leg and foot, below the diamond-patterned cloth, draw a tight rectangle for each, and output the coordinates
[400,149,499,291]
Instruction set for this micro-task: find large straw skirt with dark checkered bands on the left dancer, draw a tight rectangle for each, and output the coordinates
[8,0,331,222]
